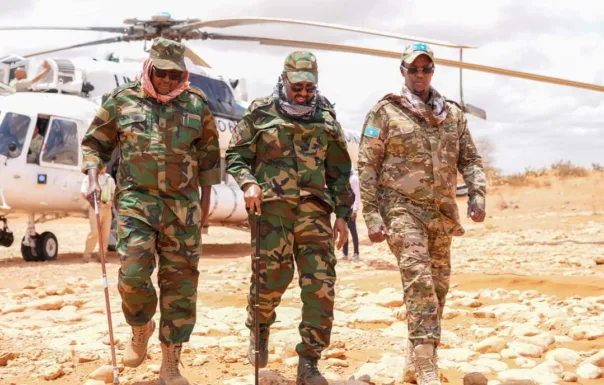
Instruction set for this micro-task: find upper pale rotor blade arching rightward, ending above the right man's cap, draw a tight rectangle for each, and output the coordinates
[174,17,475,48]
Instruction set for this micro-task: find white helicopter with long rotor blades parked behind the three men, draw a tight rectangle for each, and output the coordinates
[0,13,604,261]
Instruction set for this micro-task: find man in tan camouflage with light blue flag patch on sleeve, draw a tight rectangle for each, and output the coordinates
[358,44,486,385]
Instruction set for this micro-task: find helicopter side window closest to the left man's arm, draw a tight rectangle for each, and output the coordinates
[42,119,78,166]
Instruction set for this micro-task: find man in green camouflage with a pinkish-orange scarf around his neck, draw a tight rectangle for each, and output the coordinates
[82,38,220,385]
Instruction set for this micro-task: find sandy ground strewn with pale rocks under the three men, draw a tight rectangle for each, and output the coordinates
[0,175,604,385]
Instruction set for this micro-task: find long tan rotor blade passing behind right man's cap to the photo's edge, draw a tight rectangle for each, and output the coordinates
[207,33,604,92]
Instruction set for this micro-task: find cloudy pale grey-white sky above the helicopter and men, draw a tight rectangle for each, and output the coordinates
[0,0,604,174]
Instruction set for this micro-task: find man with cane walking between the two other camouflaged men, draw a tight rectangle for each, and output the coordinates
[226,51,354,385]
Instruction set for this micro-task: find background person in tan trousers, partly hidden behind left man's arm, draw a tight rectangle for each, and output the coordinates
[80,166,115,262]
